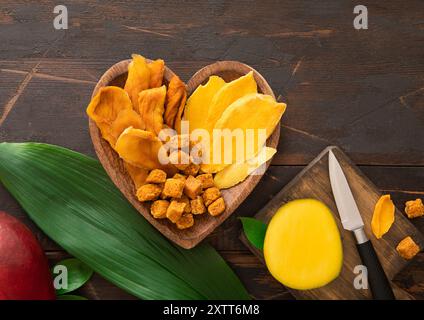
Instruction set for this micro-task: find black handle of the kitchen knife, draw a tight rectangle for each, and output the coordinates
[356,240,395,300]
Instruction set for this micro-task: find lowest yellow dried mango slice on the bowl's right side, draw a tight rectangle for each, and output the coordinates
[214,147,277,189]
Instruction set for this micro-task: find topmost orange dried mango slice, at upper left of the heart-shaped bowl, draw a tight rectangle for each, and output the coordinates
[124,54,150,111]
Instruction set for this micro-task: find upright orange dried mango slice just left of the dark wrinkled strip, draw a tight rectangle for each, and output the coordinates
[138,86,166,135]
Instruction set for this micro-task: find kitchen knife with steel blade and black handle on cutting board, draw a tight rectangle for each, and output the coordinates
[328,150,395,300]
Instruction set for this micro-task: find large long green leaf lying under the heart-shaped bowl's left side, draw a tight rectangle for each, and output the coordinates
[0,143,249,299]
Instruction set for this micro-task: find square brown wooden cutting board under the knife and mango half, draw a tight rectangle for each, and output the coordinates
[241,147,424,300]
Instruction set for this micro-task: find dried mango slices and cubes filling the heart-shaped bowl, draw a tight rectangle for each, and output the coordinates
[87,54,286,229]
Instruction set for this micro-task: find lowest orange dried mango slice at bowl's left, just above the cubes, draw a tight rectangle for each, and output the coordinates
[115,127,177,174]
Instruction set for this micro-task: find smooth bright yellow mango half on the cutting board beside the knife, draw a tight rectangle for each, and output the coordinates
[264,199,343,290]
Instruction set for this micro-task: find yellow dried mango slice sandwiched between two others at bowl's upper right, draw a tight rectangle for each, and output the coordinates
[205,71,257,132]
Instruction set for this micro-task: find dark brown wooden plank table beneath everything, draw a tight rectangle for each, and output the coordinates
[0,0,424,299]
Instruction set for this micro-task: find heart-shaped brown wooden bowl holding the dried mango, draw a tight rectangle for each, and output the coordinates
[89,60,280,249]
